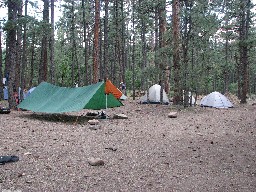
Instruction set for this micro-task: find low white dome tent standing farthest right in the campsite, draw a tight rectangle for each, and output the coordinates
[200,91,233,108]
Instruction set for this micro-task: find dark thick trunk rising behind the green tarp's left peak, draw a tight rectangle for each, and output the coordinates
[38,0,49,83]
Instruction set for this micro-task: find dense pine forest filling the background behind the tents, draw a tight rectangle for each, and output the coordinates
[0,0,256,108]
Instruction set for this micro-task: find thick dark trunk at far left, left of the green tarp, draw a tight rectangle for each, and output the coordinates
[6,0,18,109]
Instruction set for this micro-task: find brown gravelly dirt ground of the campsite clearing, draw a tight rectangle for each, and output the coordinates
[0,99,256,192]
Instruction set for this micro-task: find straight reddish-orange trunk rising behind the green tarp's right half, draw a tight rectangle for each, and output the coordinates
[93,0,100,83]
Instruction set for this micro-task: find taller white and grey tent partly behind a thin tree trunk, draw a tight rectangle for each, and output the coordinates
[140,84,169,104]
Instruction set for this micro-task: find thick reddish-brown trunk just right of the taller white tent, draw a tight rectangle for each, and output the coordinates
[172,0,182,105]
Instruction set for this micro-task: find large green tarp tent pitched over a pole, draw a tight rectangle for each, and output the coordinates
[18,82,123,113]
